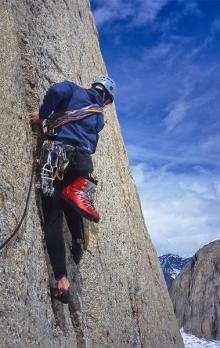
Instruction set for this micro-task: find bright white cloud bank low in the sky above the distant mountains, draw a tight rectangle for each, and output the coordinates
[133,163,220,256]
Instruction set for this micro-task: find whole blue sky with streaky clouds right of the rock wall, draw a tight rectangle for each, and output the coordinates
[91,0,220,256]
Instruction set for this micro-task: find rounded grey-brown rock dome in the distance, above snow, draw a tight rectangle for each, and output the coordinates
[170,240,220,340]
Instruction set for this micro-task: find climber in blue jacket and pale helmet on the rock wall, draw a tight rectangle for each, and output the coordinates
[29,76,115,303]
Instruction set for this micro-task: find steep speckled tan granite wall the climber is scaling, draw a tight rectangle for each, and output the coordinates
[0,0,183,348]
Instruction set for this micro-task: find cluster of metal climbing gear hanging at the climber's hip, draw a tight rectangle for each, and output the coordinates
[36,140,75,197]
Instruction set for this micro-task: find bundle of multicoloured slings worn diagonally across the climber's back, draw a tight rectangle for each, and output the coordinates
[42,104,103,136]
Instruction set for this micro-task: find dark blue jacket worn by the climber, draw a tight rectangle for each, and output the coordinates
[39,81,104,153]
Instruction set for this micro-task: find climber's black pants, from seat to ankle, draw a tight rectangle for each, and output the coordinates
[39,144,93,279]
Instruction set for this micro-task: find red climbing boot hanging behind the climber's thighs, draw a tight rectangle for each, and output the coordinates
[61,177,100,222]
